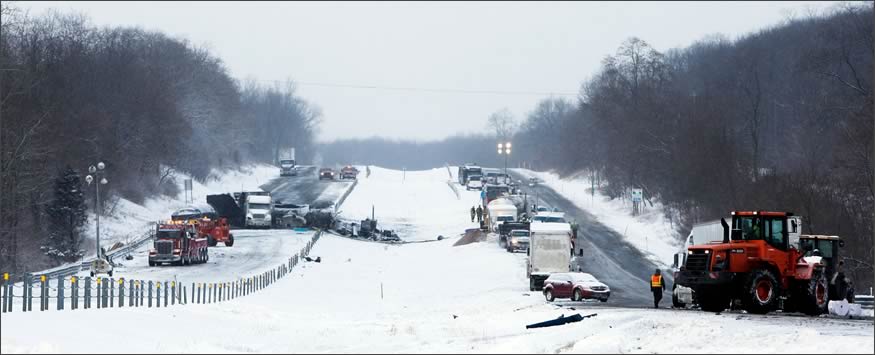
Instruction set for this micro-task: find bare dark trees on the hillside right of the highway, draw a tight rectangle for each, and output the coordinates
[514,3,875,286]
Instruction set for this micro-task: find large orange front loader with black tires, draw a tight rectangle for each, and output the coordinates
[675,211,829,315]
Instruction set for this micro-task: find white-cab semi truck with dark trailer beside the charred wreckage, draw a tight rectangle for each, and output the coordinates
[207,191,273,228]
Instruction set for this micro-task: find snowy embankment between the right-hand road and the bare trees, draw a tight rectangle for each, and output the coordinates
[513,169,681,268]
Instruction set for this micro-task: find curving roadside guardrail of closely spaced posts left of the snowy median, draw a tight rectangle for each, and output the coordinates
[0,230,322,314]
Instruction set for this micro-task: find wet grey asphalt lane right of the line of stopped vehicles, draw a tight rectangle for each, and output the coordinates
[510,171,674,307]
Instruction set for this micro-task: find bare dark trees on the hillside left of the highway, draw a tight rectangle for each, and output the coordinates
[0,3,320,272]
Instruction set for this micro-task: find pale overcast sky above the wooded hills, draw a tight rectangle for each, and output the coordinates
[18,1,833,141]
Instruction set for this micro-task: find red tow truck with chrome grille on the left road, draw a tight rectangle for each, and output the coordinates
[149,220,210,266]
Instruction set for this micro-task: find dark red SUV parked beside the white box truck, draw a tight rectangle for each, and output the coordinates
[544,272,611,302]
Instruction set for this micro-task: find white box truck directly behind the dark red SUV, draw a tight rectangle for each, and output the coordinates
[526,223,571,291]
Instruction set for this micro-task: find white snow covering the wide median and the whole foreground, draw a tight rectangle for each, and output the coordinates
[0,168,875,354]
